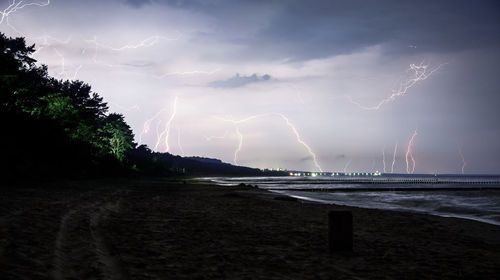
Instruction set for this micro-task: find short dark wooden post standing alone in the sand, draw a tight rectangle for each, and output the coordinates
[328,210,353,253]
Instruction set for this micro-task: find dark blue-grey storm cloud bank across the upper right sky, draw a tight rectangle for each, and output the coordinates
[150,0,500,60]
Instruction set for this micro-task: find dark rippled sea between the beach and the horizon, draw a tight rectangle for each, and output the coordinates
[200,174,500,225]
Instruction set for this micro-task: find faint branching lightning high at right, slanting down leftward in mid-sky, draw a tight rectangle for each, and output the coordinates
[347,62,446,110]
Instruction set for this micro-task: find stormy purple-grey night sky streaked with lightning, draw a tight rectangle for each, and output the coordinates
[0,0,500,174]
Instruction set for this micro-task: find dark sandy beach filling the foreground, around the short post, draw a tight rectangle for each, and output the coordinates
[0,180,500,279]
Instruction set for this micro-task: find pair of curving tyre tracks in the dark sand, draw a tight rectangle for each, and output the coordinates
[52,192,127,280]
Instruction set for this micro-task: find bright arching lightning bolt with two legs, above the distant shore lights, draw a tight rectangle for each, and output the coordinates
[217,113,323,172]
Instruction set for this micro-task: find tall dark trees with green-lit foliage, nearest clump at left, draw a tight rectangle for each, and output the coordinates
[0,33,135,177]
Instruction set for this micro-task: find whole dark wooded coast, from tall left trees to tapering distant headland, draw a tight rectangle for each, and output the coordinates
[0,33,277,179]
